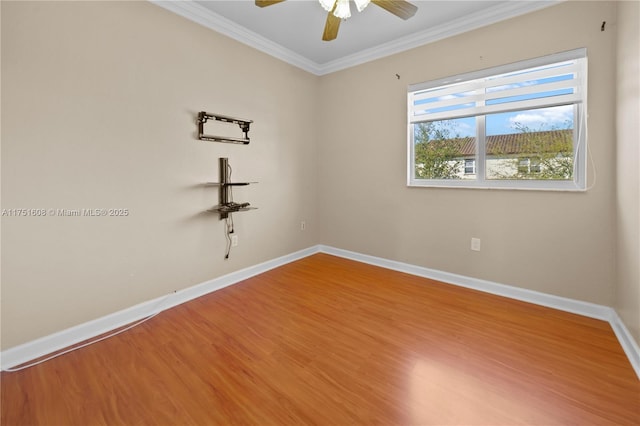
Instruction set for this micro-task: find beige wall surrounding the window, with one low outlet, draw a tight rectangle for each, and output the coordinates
[318,2,616,306]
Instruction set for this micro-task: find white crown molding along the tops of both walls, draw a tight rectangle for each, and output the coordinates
[148,0,565,76]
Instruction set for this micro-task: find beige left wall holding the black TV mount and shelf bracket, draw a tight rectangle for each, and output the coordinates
[1,1,318,349]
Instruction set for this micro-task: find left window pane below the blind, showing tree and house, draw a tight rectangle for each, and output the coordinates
[413,117,476,179]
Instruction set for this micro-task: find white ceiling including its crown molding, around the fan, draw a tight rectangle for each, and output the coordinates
[150,0,558,75]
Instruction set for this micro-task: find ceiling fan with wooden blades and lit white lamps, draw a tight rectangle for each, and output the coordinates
[255,0,418,41]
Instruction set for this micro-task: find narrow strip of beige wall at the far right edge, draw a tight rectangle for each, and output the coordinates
[615,2,640,344]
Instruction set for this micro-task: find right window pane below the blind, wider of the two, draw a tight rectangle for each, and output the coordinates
[485,105,575,180]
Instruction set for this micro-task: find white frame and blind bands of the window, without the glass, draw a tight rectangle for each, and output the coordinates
[407,48,587,191]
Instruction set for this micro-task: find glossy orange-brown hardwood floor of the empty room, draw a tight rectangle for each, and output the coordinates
[0,254,640,426]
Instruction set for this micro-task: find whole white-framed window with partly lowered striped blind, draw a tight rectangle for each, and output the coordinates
[407,49,587,191]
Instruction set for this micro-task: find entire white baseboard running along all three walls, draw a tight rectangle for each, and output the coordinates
[0,245,640,379]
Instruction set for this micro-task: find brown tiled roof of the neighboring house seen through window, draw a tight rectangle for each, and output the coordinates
[422,129,573,157]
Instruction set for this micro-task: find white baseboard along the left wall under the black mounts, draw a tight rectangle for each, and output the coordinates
[0,246,319,370]
